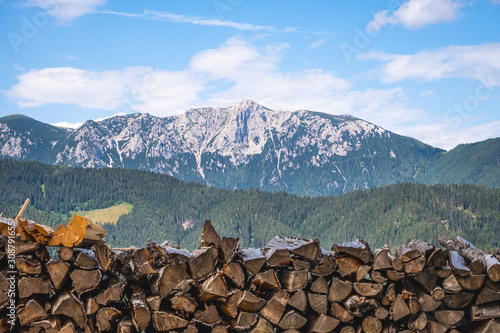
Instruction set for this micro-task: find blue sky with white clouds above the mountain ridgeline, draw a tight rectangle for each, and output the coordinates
[0,0,500,149]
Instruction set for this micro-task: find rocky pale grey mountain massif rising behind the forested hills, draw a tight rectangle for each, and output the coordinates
[0,100,443,196]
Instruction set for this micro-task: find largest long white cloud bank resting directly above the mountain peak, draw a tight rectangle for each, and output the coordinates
[4,38,423,127]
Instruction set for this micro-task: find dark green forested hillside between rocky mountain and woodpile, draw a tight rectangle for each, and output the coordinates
[0,160,500,249]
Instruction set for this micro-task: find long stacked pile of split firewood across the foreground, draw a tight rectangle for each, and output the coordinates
[0,204,500,333]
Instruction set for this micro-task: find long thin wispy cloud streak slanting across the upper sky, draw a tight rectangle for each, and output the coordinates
[99,10,276,31]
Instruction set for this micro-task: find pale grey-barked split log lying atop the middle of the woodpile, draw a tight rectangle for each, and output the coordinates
[264,236,321,261]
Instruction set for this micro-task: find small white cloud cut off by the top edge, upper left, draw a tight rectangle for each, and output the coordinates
[26,0,106,22]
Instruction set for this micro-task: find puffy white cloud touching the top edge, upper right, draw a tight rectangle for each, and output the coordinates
[367,0,463,32]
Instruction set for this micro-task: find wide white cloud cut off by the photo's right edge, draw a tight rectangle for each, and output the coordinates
[359,43,500,87]
